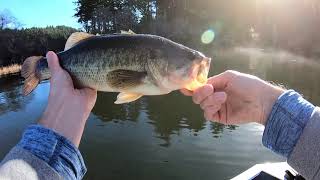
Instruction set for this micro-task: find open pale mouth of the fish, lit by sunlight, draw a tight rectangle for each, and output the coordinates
[184,57,211,91]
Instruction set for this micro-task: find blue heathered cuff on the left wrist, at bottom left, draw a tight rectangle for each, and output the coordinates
[18,125,87,179]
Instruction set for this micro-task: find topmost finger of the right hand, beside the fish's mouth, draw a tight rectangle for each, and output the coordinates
[207,70,238,89]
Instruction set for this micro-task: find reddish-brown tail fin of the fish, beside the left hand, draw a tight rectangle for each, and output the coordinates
[21,56,42,96]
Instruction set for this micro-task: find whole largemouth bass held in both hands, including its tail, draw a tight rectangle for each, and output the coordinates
[21,32,211,104]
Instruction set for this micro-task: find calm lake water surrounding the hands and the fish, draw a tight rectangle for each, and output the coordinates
[0,48,320,180]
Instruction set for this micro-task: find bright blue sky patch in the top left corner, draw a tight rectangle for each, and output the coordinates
[0,0,81,28]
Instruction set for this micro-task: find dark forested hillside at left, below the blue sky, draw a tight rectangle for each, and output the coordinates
[0,26,76,66]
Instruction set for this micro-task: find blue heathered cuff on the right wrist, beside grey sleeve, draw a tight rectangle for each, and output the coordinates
[262,90,315,157]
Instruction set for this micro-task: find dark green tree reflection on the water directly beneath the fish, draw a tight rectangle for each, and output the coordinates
[93,83,235,147]
